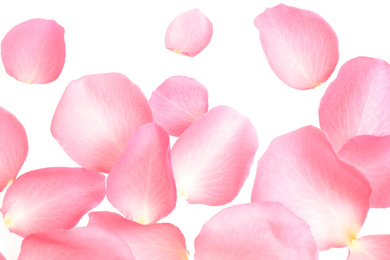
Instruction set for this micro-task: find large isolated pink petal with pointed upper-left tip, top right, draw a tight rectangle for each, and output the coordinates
[255,4,339,90]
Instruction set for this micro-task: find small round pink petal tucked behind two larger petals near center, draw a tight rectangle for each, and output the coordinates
[149,76,208,136]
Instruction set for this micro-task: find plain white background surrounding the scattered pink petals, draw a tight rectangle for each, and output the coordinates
[0,0,390,260]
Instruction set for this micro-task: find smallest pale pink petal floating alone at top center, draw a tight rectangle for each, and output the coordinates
[165,9,213,57]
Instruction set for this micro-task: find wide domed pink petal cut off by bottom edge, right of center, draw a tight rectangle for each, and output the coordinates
[195,202,318,260]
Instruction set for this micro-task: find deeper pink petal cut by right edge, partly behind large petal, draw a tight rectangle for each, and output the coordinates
[337,135,390,208]
